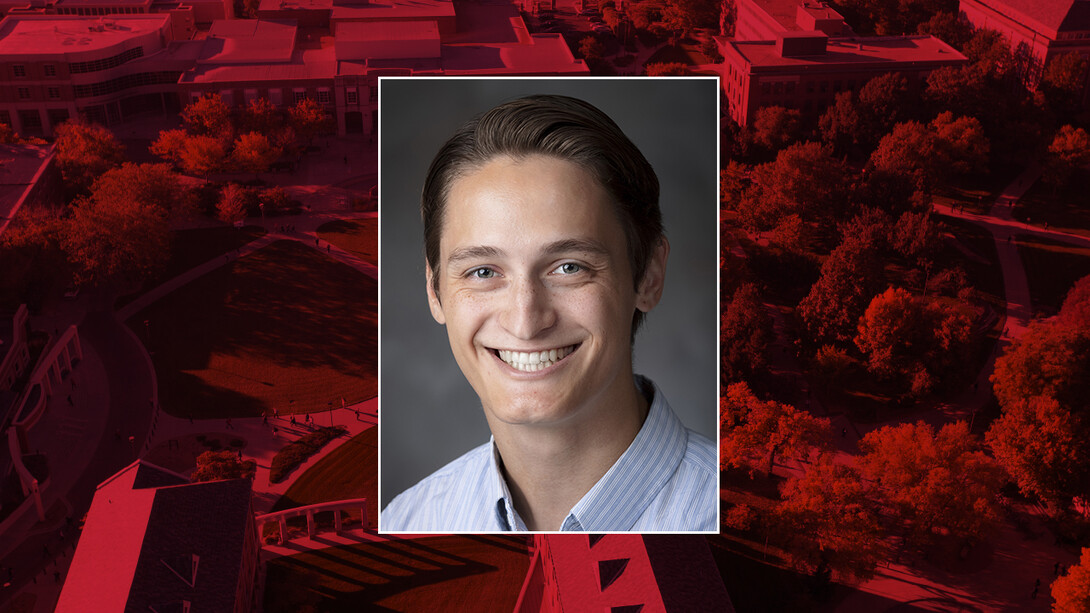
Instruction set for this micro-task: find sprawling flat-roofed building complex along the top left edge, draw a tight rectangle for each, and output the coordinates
[0,0,589,136]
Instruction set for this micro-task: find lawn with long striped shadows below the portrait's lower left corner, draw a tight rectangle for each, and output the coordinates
[265,536,530,613]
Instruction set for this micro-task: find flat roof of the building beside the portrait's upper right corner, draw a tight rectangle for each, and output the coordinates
[719,35,966,68]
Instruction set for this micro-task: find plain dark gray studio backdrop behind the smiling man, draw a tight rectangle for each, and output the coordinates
[378,77,719,508]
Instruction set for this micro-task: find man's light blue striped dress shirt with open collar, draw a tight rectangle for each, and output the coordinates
[379,376,718,532]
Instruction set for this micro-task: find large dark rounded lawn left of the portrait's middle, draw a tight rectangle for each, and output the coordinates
[129,241,377,418]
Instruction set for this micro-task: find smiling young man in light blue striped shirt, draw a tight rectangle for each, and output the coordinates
[382,96,717,531]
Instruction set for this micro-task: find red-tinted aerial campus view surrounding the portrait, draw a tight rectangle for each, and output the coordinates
[0,0,1090,613]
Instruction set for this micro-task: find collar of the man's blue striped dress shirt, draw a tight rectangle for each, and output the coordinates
[486,375,689,532]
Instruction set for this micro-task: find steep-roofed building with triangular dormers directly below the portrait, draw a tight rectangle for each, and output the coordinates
[514,534,734,613]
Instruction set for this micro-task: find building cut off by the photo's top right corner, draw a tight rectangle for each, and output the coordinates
[959,0,1090,98]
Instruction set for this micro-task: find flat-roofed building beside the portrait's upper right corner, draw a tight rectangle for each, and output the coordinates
[716,32,967,125]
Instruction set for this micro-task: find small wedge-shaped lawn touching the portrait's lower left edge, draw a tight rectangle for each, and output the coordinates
[273,428,378,519]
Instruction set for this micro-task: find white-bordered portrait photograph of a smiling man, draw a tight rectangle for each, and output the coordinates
[378,77,720,532]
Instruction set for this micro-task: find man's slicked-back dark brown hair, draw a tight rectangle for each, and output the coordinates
[421,95,663,336]
